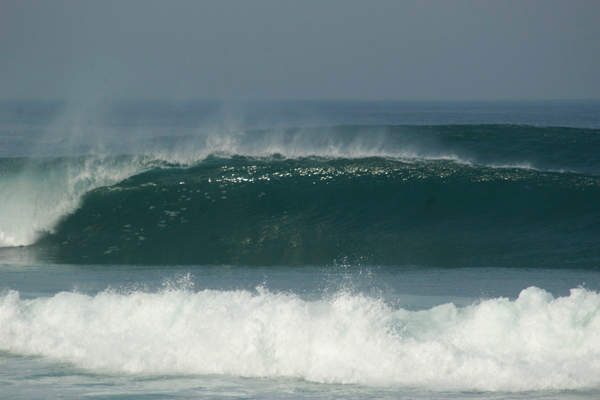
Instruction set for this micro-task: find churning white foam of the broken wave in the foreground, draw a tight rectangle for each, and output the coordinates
[0,287,600,391]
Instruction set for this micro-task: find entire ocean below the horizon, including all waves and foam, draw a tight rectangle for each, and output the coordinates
[0,99,600,399]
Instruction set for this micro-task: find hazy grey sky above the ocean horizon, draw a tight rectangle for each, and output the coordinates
[0,0,600,100]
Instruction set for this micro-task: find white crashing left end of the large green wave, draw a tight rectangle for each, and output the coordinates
[0,156,144,247]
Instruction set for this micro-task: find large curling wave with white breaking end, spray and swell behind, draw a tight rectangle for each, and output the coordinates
[0,126,600,268]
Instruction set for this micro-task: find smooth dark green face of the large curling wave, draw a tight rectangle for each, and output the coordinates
[22,157,600,268]
